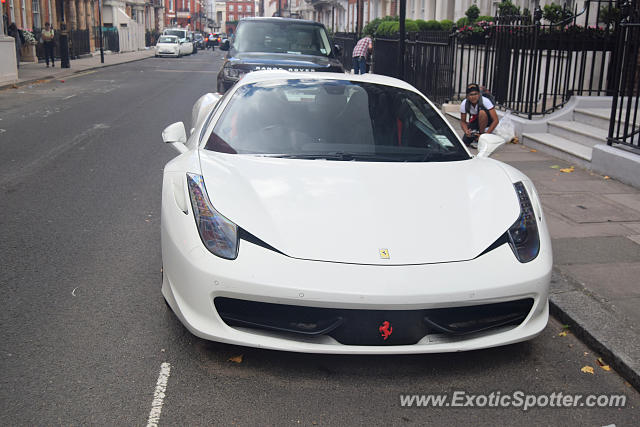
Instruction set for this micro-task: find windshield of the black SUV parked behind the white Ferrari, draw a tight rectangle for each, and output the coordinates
[233,21,331,56]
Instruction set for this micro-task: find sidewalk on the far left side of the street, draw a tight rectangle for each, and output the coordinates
[0,49,154,90]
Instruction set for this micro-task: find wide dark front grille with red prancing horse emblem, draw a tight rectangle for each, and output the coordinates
[214,297,533,345]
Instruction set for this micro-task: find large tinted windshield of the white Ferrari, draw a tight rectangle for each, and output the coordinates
[205,80,469,162]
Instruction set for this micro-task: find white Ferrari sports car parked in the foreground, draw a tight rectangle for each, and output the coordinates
[161,70,553,354]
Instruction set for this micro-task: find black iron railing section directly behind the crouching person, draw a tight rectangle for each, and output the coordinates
[454,0,616,119]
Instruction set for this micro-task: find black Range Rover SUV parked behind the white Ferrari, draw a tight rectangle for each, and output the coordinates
[218,18,344,93]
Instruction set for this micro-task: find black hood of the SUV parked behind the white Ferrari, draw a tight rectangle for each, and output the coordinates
[229,52,336,71]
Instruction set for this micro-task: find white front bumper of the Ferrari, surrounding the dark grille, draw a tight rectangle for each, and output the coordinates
[162,185,552,354]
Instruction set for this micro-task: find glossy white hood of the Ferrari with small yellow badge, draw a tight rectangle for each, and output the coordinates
[200,150,520,265]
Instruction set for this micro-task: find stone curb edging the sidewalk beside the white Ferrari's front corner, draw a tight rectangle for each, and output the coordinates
[549,267,640,391]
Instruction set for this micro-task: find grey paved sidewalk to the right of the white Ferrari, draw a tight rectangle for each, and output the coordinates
[448,118,640,390]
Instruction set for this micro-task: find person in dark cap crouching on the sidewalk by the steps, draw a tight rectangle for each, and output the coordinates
[460,83,498,148]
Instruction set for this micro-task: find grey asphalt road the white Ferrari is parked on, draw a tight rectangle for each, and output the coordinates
[0,51,640,426]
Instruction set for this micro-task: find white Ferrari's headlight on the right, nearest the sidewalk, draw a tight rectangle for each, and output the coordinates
[507,182,540,263]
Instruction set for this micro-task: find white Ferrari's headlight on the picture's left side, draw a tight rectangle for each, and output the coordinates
[187,173,238,259]
